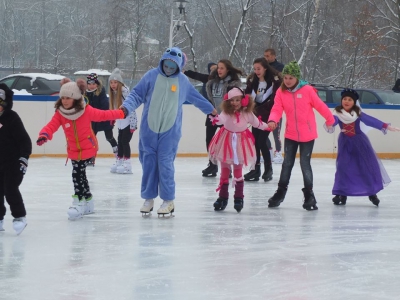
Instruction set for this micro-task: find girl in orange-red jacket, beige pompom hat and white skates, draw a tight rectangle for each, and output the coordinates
[36,79,124,220]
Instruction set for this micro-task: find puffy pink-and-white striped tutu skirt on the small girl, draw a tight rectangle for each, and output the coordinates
[208,127,257,170]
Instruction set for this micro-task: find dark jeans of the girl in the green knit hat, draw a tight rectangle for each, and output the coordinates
[278,138,314,189]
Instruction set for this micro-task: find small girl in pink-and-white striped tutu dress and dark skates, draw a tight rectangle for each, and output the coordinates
[208,87,268,212]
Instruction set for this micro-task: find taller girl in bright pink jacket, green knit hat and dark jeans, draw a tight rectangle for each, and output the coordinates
[268,61,335,210]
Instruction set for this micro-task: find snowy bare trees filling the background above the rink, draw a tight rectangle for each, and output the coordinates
[0,0,400,88]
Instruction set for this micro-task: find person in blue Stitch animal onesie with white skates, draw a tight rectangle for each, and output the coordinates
[121,47,217,215]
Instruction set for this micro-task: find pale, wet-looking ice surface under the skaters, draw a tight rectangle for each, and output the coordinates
[0,158,400,300]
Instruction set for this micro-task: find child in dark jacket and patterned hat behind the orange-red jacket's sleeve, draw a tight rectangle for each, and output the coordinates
[86,73,118,166]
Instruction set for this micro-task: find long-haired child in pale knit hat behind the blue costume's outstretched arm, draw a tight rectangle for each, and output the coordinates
[109,68,137,174]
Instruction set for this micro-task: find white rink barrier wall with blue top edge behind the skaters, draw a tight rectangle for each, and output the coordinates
[13,95,400,159]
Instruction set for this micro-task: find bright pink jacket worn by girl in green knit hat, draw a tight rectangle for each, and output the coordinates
[268,82,335,142]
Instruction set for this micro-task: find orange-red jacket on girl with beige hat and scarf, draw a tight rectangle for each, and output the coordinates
[39,105,124,160]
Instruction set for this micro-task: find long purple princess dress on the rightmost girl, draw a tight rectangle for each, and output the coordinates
[332,112,391,196]
